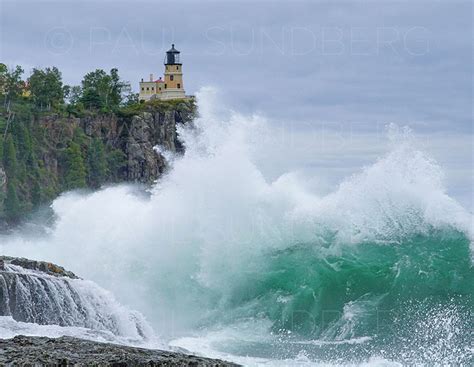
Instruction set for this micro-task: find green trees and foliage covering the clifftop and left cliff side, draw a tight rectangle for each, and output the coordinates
[0,63,196,223]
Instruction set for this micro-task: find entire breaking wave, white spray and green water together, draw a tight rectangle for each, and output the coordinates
[1,90,474,365]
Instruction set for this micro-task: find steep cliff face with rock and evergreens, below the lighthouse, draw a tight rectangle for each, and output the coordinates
[0,100,197,227]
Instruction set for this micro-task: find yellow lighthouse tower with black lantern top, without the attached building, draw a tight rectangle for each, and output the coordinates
[162,44,186,99]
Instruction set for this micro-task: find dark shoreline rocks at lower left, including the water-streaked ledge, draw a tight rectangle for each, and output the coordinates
[0,256,236,367]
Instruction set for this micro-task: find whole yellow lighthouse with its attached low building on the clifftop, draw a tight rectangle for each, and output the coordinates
[139,44,188,101]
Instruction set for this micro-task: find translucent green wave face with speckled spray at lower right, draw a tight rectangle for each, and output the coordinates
[205,229,474,365]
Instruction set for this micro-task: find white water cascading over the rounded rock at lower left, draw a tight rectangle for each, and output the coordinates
[0,257,154,343]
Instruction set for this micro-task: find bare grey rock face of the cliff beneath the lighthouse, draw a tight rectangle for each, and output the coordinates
[40,101,196,183]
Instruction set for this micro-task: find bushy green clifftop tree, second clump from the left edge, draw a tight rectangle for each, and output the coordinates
[28,67,67,110]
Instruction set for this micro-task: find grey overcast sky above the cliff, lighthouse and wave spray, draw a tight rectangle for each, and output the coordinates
[0,0,473,208]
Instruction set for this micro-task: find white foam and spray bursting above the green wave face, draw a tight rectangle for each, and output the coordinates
[0,89,472,362]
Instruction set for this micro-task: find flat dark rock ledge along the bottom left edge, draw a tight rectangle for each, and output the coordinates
[0,336,237,367]
